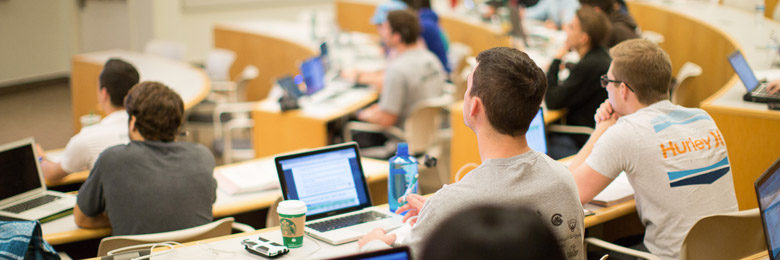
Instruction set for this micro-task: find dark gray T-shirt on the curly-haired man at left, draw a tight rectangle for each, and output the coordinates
[77,141,217,235]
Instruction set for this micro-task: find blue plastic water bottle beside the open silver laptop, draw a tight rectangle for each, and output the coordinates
[387,143,417,212]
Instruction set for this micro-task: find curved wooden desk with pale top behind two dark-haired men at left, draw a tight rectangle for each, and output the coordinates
[70,50,211,133]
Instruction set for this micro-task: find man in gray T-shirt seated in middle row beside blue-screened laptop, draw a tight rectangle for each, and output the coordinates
[355,10,447,147]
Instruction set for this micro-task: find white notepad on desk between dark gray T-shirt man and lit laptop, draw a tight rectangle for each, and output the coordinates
[214,160,279,195]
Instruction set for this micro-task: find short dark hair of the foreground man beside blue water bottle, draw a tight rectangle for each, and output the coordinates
[469,47,547,136]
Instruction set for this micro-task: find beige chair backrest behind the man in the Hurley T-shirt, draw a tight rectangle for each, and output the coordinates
[680,208,766,259]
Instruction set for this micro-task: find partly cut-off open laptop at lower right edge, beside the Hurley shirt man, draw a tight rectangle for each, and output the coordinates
[755,156,780,260]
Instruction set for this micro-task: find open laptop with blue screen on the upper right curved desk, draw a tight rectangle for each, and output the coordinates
[729,50,780,103]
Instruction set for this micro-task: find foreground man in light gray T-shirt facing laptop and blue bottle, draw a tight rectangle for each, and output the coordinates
[358,47,584,259]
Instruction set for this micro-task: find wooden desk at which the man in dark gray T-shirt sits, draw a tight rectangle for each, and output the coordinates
[42,157,388,245]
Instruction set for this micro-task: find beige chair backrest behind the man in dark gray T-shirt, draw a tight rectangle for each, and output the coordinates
[98,217,234,257]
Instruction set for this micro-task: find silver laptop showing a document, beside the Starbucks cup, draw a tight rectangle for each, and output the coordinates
[274,142,403,245]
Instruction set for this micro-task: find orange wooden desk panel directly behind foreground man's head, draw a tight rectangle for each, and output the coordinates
[450,101,564,183]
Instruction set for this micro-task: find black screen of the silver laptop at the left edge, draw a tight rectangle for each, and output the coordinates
[0,144,43,200]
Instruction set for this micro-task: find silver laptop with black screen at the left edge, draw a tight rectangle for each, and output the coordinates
[0,138,76,220]
